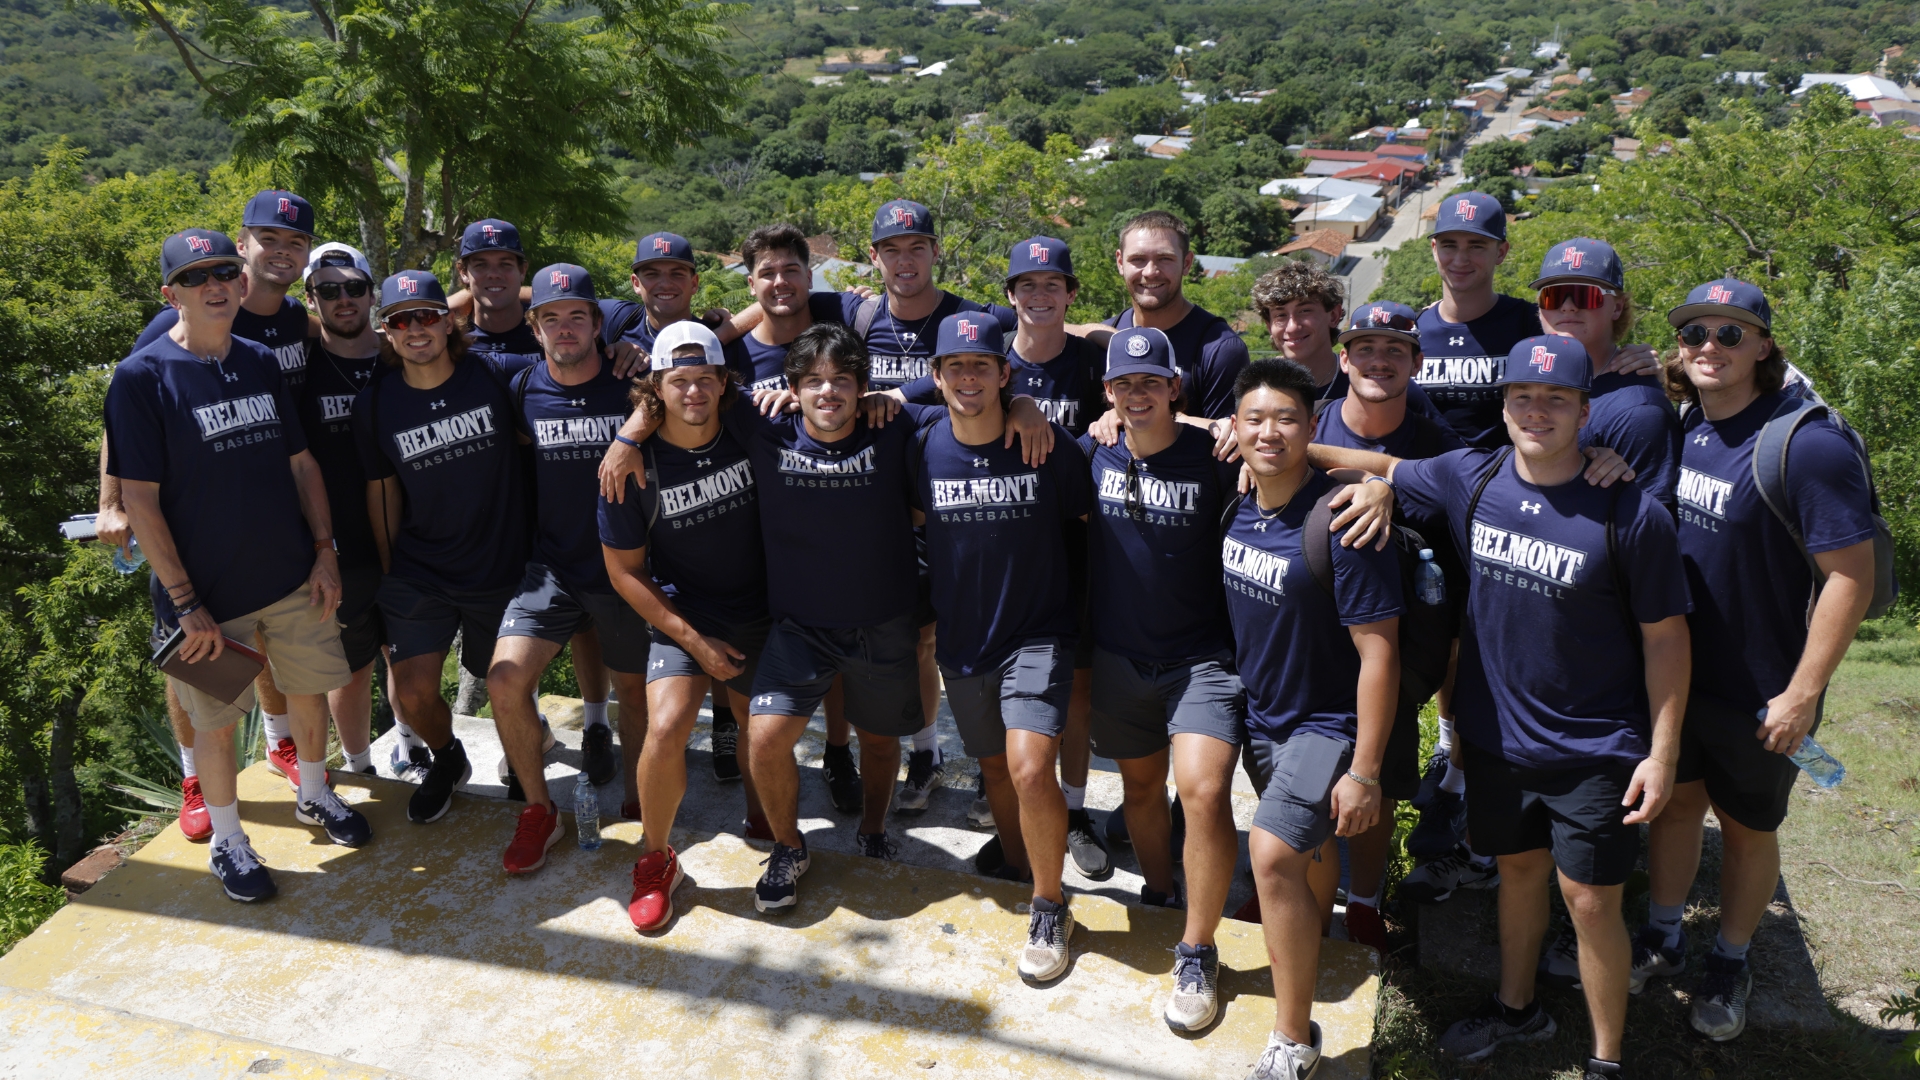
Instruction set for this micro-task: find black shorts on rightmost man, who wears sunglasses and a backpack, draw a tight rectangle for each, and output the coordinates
[1674,694,1826,832]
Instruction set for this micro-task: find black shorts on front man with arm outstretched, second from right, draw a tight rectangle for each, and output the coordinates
[1467,742,1640,886]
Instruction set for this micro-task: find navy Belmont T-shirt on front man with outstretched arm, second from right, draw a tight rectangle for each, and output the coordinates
[1394,450,1692,769]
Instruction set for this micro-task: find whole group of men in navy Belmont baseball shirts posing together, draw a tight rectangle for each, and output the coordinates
[100,192,1876,1080]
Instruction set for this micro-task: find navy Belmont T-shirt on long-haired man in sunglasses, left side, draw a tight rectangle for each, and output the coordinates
[353,354,536,592]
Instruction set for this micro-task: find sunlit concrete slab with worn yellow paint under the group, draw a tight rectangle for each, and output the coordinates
[0,767,1379,1080]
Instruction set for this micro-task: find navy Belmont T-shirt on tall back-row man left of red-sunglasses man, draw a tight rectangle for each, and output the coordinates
[1413,294,1540,448]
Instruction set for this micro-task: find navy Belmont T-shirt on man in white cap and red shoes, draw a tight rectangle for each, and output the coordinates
[599,422,766,628]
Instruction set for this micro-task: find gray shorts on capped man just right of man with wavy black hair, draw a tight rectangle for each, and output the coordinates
[941,638,1073,759]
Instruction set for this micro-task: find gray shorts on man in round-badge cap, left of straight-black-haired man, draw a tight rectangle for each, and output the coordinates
[1089,650,1246,761]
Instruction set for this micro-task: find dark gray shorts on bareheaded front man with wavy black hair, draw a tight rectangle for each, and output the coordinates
[749,613,925,736]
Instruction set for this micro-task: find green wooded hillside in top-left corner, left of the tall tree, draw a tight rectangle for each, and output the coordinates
[0,0,230,179]
